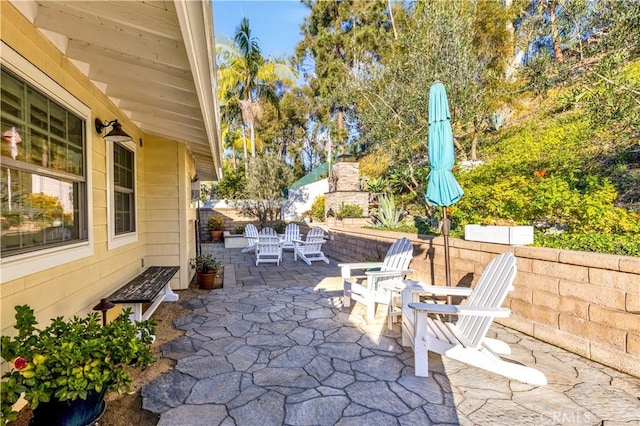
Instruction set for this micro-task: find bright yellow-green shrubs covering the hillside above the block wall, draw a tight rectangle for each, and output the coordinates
[450,61,640,256]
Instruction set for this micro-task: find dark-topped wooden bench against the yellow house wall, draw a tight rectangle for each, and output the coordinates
[107,266,180,322]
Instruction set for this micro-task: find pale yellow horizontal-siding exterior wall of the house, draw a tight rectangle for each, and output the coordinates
[0,2,195,334]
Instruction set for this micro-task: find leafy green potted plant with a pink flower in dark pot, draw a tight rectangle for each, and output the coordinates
[0,305,155,425]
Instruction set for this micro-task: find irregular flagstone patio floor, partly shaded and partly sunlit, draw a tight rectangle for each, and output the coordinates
[142,245,640,425]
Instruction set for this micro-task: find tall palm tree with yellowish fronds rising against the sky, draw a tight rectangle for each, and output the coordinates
[216,18,296,162]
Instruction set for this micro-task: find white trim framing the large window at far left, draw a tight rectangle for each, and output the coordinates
[0,42,94,283]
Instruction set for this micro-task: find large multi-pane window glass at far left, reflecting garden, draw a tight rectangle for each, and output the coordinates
[0,68,89,260]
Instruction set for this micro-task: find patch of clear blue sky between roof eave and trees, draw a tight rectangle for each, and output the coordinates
[213,0,309,57]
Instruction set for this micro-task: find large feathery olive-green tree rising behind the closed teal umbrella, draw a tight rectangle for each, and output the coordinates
[344,2,511,210]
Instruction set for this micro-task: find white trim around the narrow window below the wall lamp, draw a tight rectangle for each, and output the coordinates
[105,140,139,250]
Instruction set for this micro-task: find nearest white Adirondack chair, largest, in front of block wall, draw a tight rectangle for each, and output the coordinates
[402,253,547,385]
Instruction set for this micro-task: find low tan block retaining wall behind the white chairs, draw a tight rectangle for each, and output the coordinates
[324,228,640,377]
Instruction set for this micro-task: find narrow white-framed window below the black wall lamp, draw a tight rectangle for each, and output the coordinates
[107,141,138,249]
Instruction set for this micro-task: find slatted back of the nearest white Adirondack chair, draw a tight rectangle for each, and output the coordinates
[456,253,517,347]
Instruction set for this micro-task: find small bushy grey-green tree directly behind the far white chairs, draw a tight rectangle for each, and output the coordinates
[239,153,293,226]
